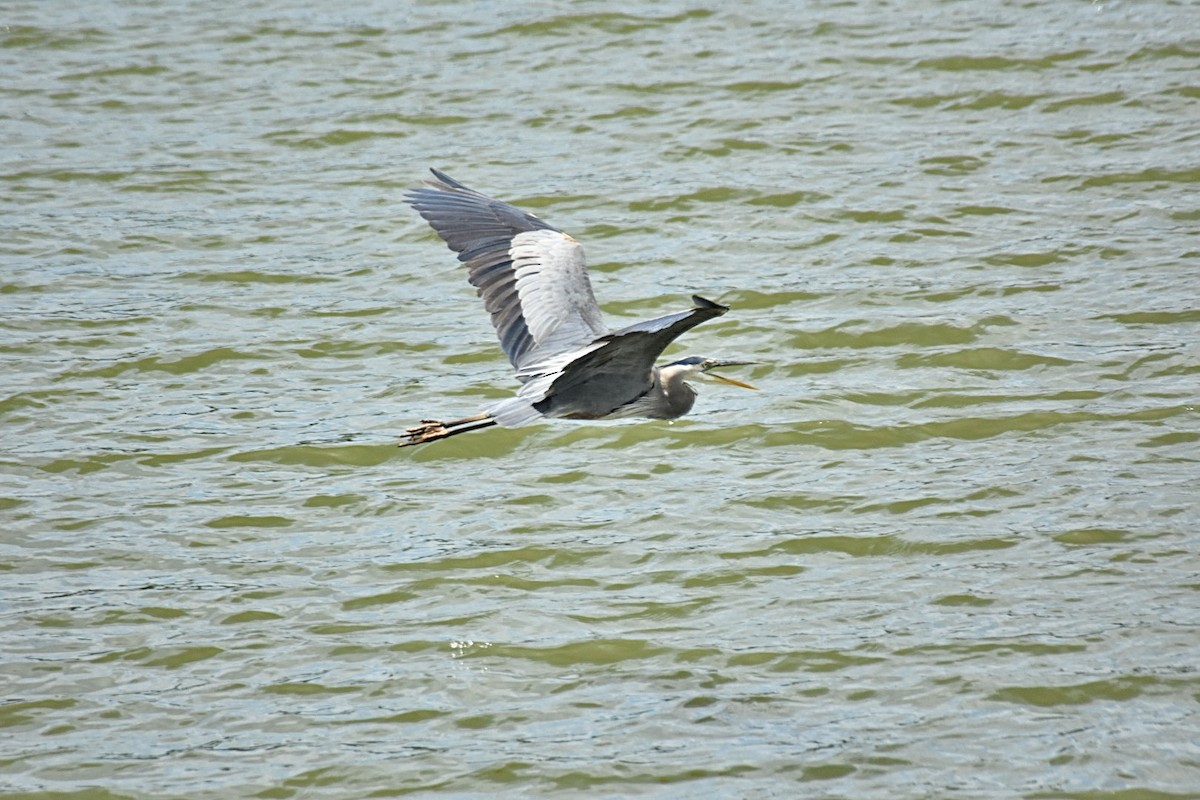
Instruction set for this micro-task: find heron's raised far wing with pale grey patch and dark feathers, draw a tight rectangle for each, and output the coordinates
[407,169,608,380]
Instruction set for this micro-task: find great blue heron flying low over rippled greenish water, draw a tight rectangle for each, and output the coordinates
[401,169,755,447]
